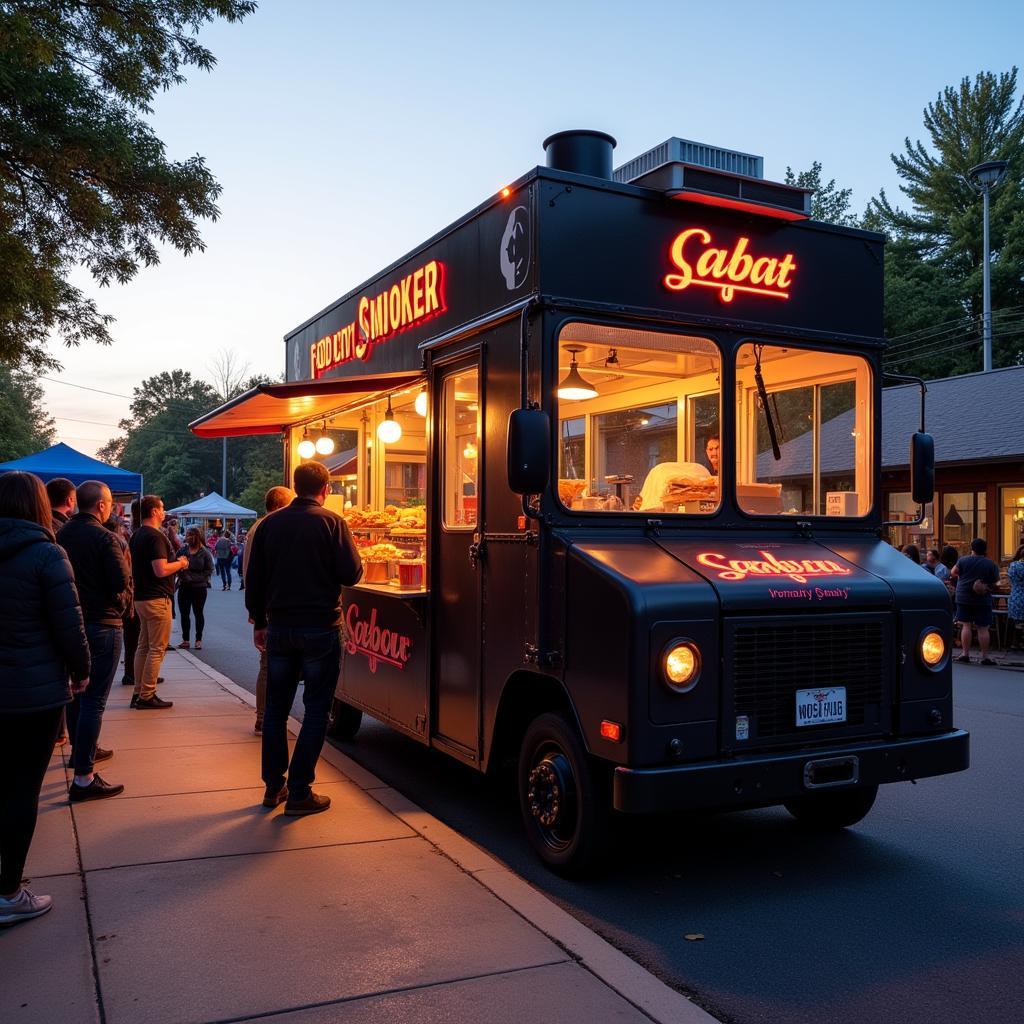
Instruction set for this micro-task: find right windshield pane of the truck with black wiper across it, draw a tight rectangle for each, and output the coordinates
[736,342,872,517]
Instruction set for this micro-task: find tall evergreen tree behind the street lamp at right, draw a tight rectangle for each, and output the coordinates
[865,68,1024,377]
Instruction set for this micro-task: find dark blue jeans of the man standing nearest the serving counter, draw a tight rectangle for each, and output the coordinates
[263,626,341,801]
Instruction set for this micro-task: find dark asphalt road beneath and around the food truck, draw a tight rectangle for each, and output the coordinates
[184,590,1024,1024]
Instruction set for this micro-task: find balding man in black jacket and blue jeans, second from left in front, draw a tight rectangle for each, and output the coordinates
[57,480,131,802]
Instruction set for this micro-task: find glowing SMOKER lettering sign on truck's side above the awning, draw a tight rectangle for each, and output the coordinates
[309,259,447,380]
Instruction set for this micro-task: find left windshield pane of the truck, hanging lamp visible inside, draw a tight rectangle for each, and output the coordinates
[556,324,721,515]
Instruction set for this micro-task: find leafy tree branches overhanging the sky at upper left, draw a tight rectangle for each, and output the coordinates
[0,0,256,368]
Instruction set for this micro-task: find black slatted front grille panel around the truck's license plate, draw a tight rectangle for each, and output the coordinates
[722,613,895,754]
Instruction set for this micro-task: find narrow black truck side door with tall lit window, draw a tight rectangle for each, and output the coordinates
[431,354,483,760]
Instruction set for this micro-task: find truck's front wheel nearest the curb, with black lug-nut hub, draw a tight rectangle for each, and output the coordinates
[518,714,609,874]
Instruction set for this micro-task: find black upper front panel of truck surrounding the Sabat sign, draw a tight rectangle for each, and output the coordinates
[537,172,883,338]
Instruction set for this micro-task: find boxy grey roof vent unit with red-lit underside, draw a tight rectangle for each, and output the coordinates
[613,138,812,220]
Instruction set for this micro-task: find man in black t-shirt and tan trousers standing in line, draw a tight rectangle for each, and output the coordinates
[129,495,188,711]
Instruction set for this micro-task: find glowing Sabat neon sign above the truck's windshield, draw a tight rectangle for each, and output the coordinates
[665,227,797,302]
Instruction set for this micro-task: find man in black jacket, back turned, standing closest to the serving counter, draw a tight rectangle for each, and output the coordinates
[246,462,362,815]
